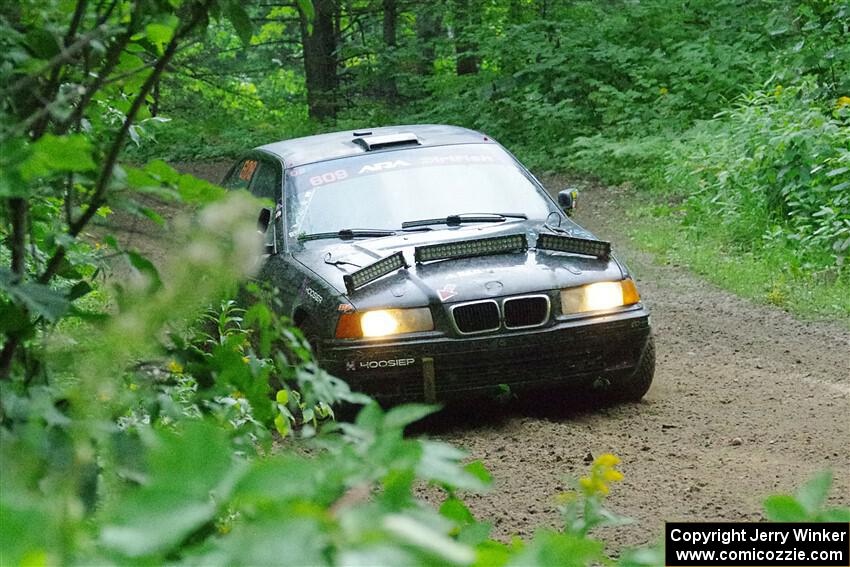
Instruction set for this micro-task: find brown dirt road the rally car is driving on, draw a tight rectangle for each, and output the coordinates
[139,164,850,549]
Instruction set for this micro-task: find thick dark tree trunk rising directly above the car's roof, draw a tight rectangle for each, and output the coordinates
[300,0,339,120]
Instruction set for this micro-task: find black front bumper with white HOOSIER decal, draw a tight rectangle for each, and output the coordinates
[319,305,650,401]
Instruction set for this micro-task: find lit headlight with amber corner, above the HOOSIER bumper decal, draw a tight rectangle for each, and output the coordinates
[336,307,434,339]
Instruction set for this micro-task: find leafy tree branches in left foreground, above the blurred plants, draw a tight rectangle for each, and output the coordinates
[0,0,272,380]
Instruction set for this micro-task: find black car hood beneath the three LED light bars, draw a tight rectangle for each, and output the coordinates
[293,221,625,309]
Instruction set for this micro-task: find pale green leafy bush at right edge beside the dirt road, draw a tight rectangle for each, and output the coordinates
[666,87,850,270]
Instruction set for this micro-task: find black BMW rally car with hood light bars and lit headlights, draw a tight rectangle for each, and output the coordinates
[224,125,655,401]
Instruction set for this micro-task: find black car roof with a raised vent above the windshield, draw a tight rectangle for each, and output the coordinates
[255,124,492,167]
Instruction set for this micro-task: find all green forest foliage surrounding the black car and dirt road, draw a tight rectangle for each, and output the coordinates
[0,0,850,566]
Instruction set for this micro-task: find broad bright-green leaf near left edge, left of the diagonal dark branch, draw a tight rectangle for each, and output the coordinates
[21,134,95,181]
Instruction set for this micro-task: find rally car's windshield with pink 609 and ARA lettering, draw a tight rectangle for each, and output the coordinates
[286,144,554,237]
